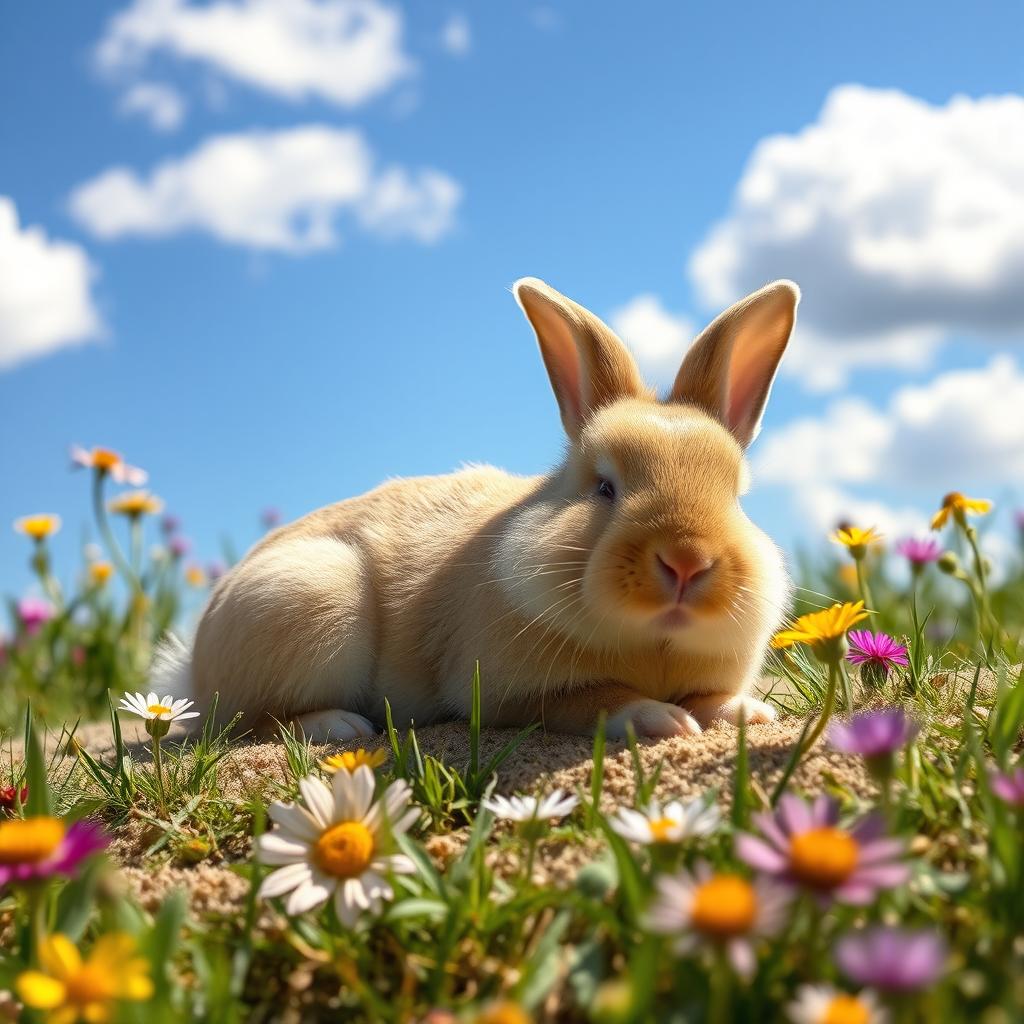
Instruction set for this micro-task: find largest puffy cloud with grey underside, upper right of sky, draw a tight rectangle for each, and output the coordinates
[689,85,1024,388]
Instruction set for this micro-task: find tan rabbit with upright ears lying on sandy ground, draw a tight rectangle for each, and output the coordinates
[176,278,800,741]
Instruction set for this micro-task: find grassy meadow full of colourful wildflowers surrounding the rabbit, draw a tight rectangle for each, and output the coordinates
[0,450,1024,1024]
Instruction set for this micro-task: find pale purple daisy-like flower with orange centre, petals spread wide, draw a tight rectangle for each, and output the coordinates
[736,794,909,905]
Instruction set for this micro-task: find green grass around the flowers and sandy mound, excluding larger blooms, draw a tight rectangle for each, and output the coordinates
[0,466,1024,1024]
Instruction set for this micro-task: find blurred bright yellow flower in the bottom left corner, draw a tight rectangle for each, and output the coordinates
[15,933,153,1024]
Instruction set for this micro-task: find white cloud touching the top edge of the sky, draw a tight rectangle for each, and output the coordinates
[96,0,413,108]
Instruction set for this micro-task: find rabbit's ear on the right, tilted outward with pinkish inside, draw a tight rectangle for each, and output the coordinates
[669,281,800,447]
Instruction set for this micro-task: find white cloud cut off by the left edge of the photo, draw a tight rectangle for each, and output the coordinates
[0,196,102,370]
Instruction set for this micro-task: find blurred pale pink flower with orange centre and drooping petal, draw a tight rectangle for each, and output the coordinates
[646,861,788,977]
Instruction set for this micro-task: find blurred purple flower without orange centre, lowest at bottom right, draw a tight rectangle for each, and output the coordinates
[836,928,947,992]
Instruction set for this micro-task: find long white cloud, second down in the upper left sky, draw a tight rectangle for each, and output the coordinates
[71,125,461,253]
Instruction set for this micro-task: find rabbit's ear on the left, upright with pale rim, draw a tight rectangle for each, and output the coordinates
[512,278,647,438]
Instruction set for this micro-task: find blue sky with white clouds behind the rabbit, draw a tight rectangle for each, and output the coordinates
[0,0,1024,592]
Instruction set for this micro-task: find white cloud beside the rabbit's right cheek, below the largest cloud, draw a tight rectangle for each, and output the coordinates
[755,354,1024,534]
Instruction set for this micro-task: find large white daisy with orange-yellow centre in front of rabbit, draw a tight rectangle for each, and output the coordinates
[258,765,420,928]
